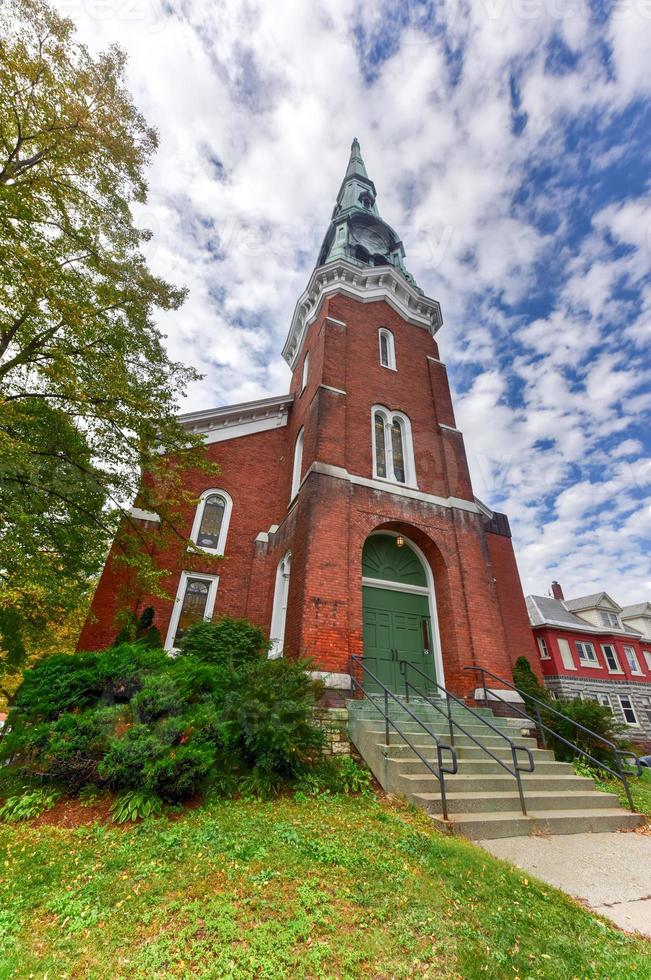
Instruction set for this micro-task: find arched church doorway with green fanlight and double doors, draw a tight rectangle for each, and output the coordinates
[362,531,444,694]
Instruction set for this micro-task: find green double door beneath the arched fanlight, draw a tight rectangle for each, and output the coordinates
[362,586,436,695]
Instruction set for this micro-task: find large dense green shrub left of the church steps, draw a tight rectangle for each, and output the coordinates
[0,617,324,803]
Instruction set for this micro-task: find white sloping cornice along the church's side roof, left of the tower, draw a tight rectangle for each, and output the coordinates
[179,395,294,443]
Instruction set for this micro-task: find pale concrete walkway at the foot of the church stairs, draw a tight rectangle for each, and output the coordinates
[476,833,651,939]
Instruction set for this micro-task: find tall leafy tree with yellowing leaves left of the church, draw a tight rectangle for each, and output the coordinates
[0,0,215,668]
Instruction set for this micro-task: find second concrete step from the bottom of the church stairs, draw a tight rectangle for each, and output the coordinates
[406,776,612,815]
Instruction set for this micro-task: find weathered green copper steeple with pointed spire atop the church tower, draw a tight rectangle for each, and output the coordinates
[317,138,420,291]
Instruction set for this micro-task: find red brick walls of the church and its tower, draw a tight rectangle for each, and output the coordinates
[80,286,535,694]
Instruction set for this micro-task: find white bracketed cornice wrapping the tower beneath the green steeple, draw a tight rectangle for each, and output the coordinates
[283,259,443,369]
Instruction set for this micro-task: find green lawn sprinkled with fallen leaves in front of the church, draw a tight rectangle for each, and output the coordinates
[0,796,651,980]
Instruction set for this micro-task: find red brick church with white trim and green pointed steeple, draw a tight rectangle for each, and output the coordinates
[79,140,537,697]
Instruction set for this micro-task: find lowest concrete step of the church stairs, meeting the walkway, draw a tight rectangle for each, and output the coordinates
[426,808,644,840]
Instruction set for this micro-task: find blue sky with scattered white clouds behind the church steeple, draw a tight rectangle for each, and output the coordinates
[58,0,651,604]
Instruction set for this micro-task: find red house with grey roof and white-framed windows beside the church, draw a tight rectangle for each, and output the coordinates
[527,582,651,741]
